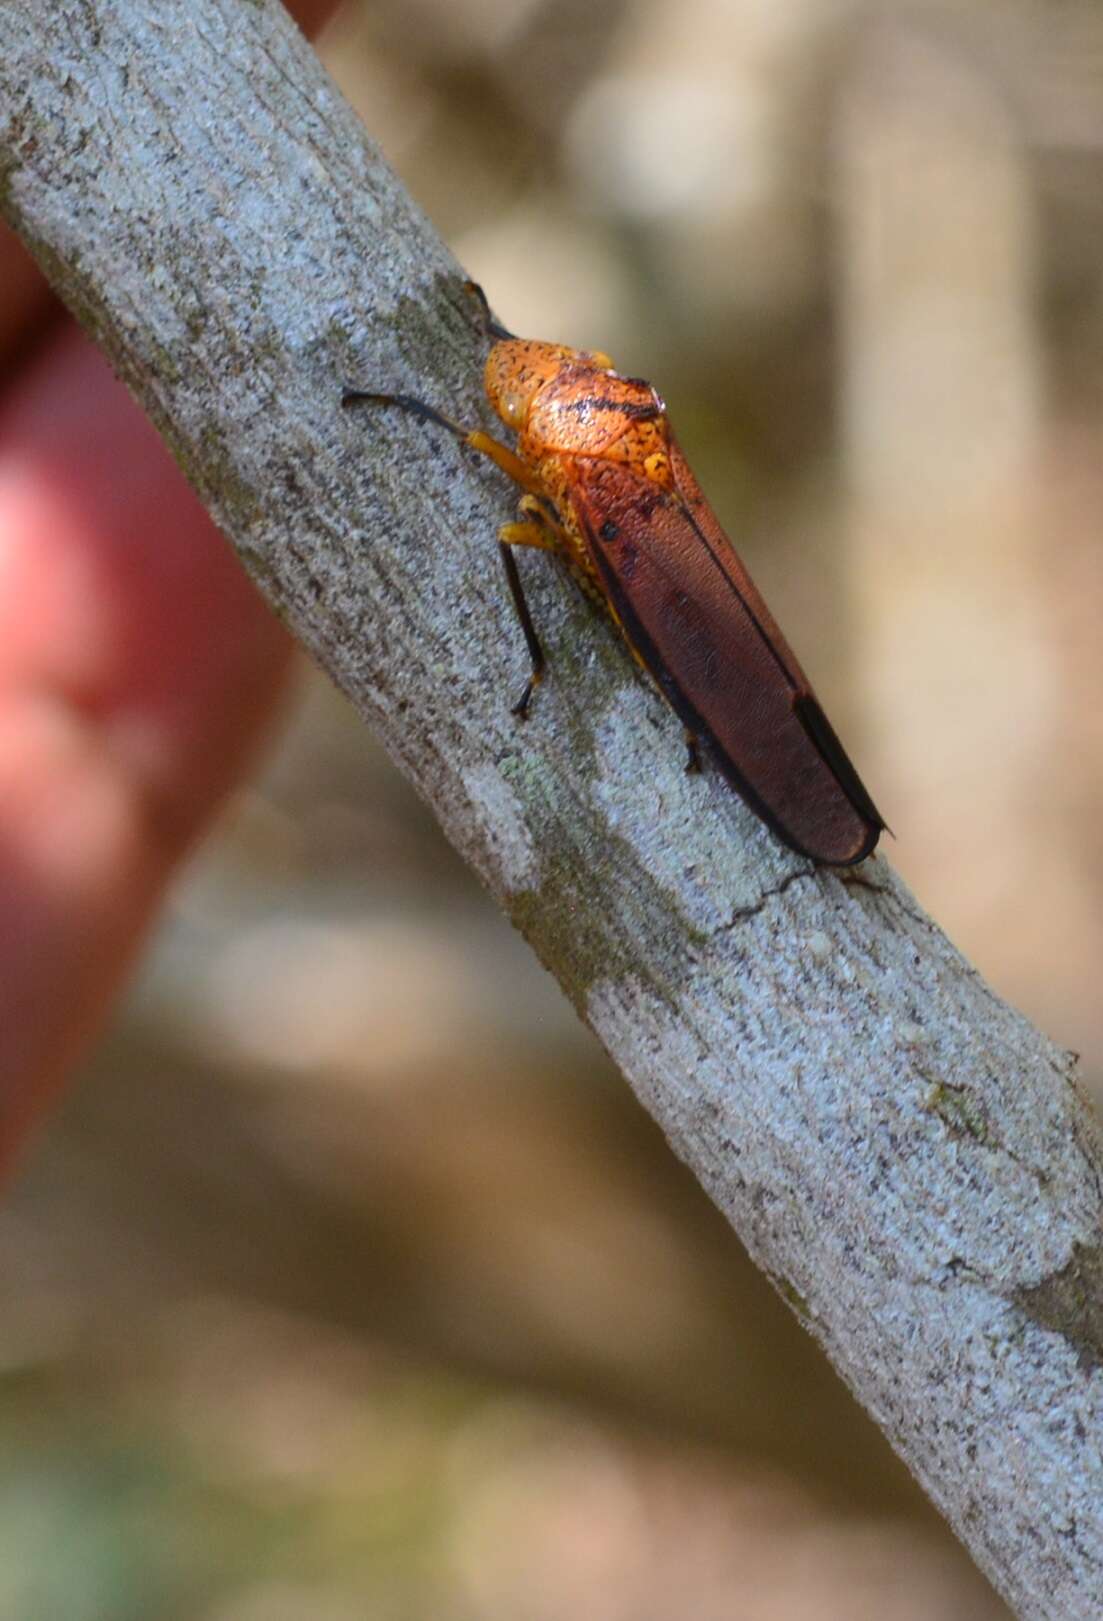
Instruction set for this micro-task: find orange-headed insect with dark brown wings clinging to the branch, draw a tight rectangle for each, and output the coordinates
[342,284,886,867]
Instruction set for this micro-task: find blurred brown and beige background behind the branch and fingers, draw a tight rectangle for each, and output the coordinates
[0,0,1103,1621]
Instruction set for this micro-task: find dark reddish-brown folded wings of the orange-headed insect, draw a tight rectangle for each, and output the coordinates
[571,444,884,866]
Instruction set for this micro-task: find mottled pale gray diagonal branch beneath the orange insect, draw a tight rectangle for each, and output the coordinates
[0,0,1103,1621]
